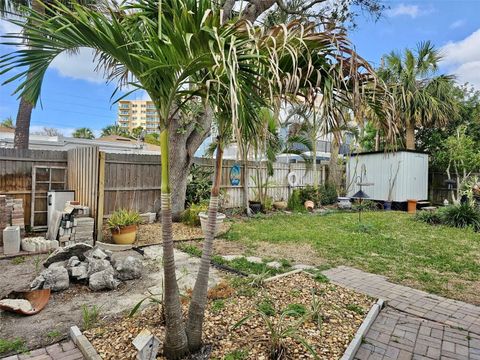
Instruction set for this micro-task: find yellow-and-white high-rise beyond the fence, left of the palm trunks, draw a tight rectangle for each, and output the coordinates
[117,100,160,133]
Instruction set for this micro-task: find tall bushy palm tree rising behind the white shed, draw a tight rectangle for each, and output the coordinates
[378,41,458,150]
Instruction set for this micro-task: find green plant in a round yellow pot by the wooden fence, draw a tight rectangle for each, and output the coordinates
[107,209,140,245]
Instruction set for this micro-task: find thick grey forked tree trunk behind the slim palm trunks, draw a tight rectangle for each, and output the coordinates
[168,108,212,221]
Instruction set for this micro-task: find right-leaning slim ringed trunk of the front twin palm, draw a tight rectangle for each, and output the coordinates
[187,141,223,351]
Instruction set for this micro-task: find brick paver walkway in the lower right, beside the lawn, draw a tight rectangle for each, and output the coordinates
[324,266,480,360]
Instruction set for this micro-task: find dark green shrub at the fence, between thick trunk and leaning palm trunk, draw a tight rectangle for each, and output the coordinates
[185,164,213,207]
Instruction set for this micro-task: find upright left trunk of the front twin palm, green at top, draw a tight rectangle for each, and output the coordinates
[160,130,188,359]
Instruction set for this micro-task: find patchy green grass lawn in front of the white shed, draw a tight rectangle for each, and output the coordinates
[226,211,480,304]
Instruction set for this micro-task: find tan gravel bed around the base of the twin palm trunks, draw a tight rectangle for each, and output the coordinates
[85,273,374,360]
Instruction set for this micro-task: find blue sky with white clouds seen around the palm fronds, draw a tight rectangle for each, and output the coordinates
[0,0,480,136]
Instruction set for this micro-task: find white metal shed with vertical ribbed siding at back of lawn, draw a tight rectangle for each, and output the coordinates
[346,150,428,202]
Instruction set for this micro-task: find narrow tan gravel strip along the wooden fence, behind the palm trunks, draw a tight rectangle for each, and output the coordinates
[103,222,231,246]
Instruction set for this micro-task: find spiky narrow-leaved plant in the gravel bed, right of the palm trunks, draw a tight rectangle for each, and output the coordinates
[233,310,318,359]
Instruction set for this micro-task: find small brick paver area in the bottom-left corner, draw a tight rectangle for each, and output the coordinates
[2,340,84,360]
